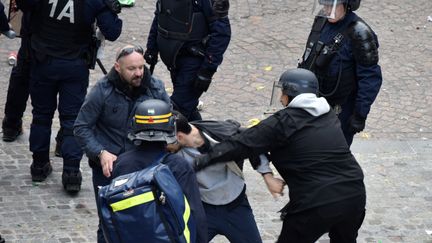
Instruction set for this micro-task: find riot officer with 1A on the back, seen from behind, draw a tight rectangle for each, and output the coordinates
[18,0,122,193]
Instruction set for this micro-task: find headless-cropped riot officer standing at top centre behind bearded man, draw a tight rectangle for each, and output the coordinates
[145,0,231,121]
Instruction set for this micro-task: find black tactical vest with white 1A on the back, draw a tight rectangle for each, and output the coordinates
[32,0,92,59]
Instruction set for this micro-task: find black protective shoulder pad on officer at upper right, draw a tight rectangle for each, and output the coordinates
[348,20,378,66]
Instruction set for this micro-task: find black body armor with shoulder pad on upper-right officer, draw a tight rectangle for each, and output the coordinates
[299,17,378,106]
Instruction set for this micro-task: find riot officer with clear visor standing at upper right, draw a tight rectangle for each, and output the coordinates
[299,0,382,145]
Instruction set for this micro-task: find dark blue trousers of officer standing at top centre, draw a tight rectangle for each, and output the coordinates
[171,56,203,121]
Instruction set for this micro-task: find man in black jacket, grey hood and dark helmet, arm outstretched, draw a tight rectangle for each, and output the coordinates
[195,69,366,243]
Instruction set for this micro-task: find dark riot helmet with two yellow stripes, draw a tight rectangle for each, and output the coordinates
[128,99,177,144]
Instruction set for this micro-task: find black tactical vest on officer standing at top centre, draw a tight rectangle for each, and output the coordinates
[157,0,208,67]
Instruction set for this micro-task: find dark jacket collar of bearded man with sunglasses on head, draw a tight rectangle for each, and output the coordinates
[107,66,151,100]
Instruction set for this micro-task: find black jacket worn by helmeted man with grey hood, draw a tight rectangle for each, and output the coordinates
[202,108,365,213]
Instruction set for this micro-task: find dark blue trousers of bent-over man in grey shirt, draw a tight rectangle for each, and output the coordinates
[203,194,262,243]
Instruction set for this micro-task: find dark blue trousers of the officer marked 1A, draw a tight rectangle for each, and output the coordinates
[30,57,89,169]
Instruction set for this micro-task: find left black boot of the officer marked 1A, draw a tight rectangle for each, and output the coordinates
[30,151,52,182]
